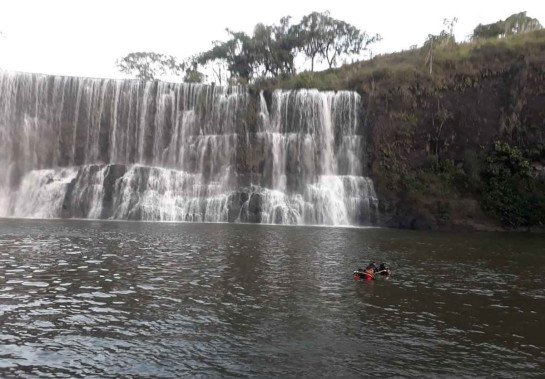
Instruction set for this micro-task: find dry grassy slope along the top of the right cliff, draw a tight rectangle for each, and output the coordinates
[256,26,545,93]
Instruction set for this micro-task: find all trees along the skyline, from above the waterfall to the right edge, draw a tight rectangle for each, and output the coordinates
[117,12,542,85]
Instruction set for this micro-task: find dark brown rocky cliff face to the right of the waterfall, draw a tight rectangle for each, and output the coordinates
[360,35,545,230]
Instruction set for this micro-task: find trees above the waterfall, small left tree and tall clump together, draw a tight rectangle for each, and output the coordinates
[117,12,381,84]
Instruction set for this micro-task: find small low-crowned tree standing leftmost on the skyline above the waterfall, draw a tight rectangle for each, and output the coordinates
[116,52,186,81]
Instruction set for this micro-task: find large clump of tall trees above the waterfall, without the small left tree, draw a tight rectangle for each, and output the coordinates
[198,12,381,80]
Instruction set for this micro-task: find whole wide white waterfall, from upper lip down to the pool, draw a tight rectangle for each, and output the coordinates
[0,72,376,225]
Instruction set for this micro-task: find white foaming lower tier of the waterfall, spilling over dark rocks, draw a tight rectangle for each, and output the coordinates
[5,166,377,226]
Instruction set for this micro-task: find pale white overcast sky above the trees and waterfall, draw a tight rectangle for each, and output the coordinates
[0,0,545,78]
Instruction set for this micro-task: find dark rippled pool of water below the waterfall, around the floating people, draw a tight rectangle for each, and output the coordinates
[0,219,545,377]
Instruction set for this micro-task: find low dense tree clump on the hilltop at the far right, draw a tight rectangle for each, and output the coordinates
[472,12,543,39]
